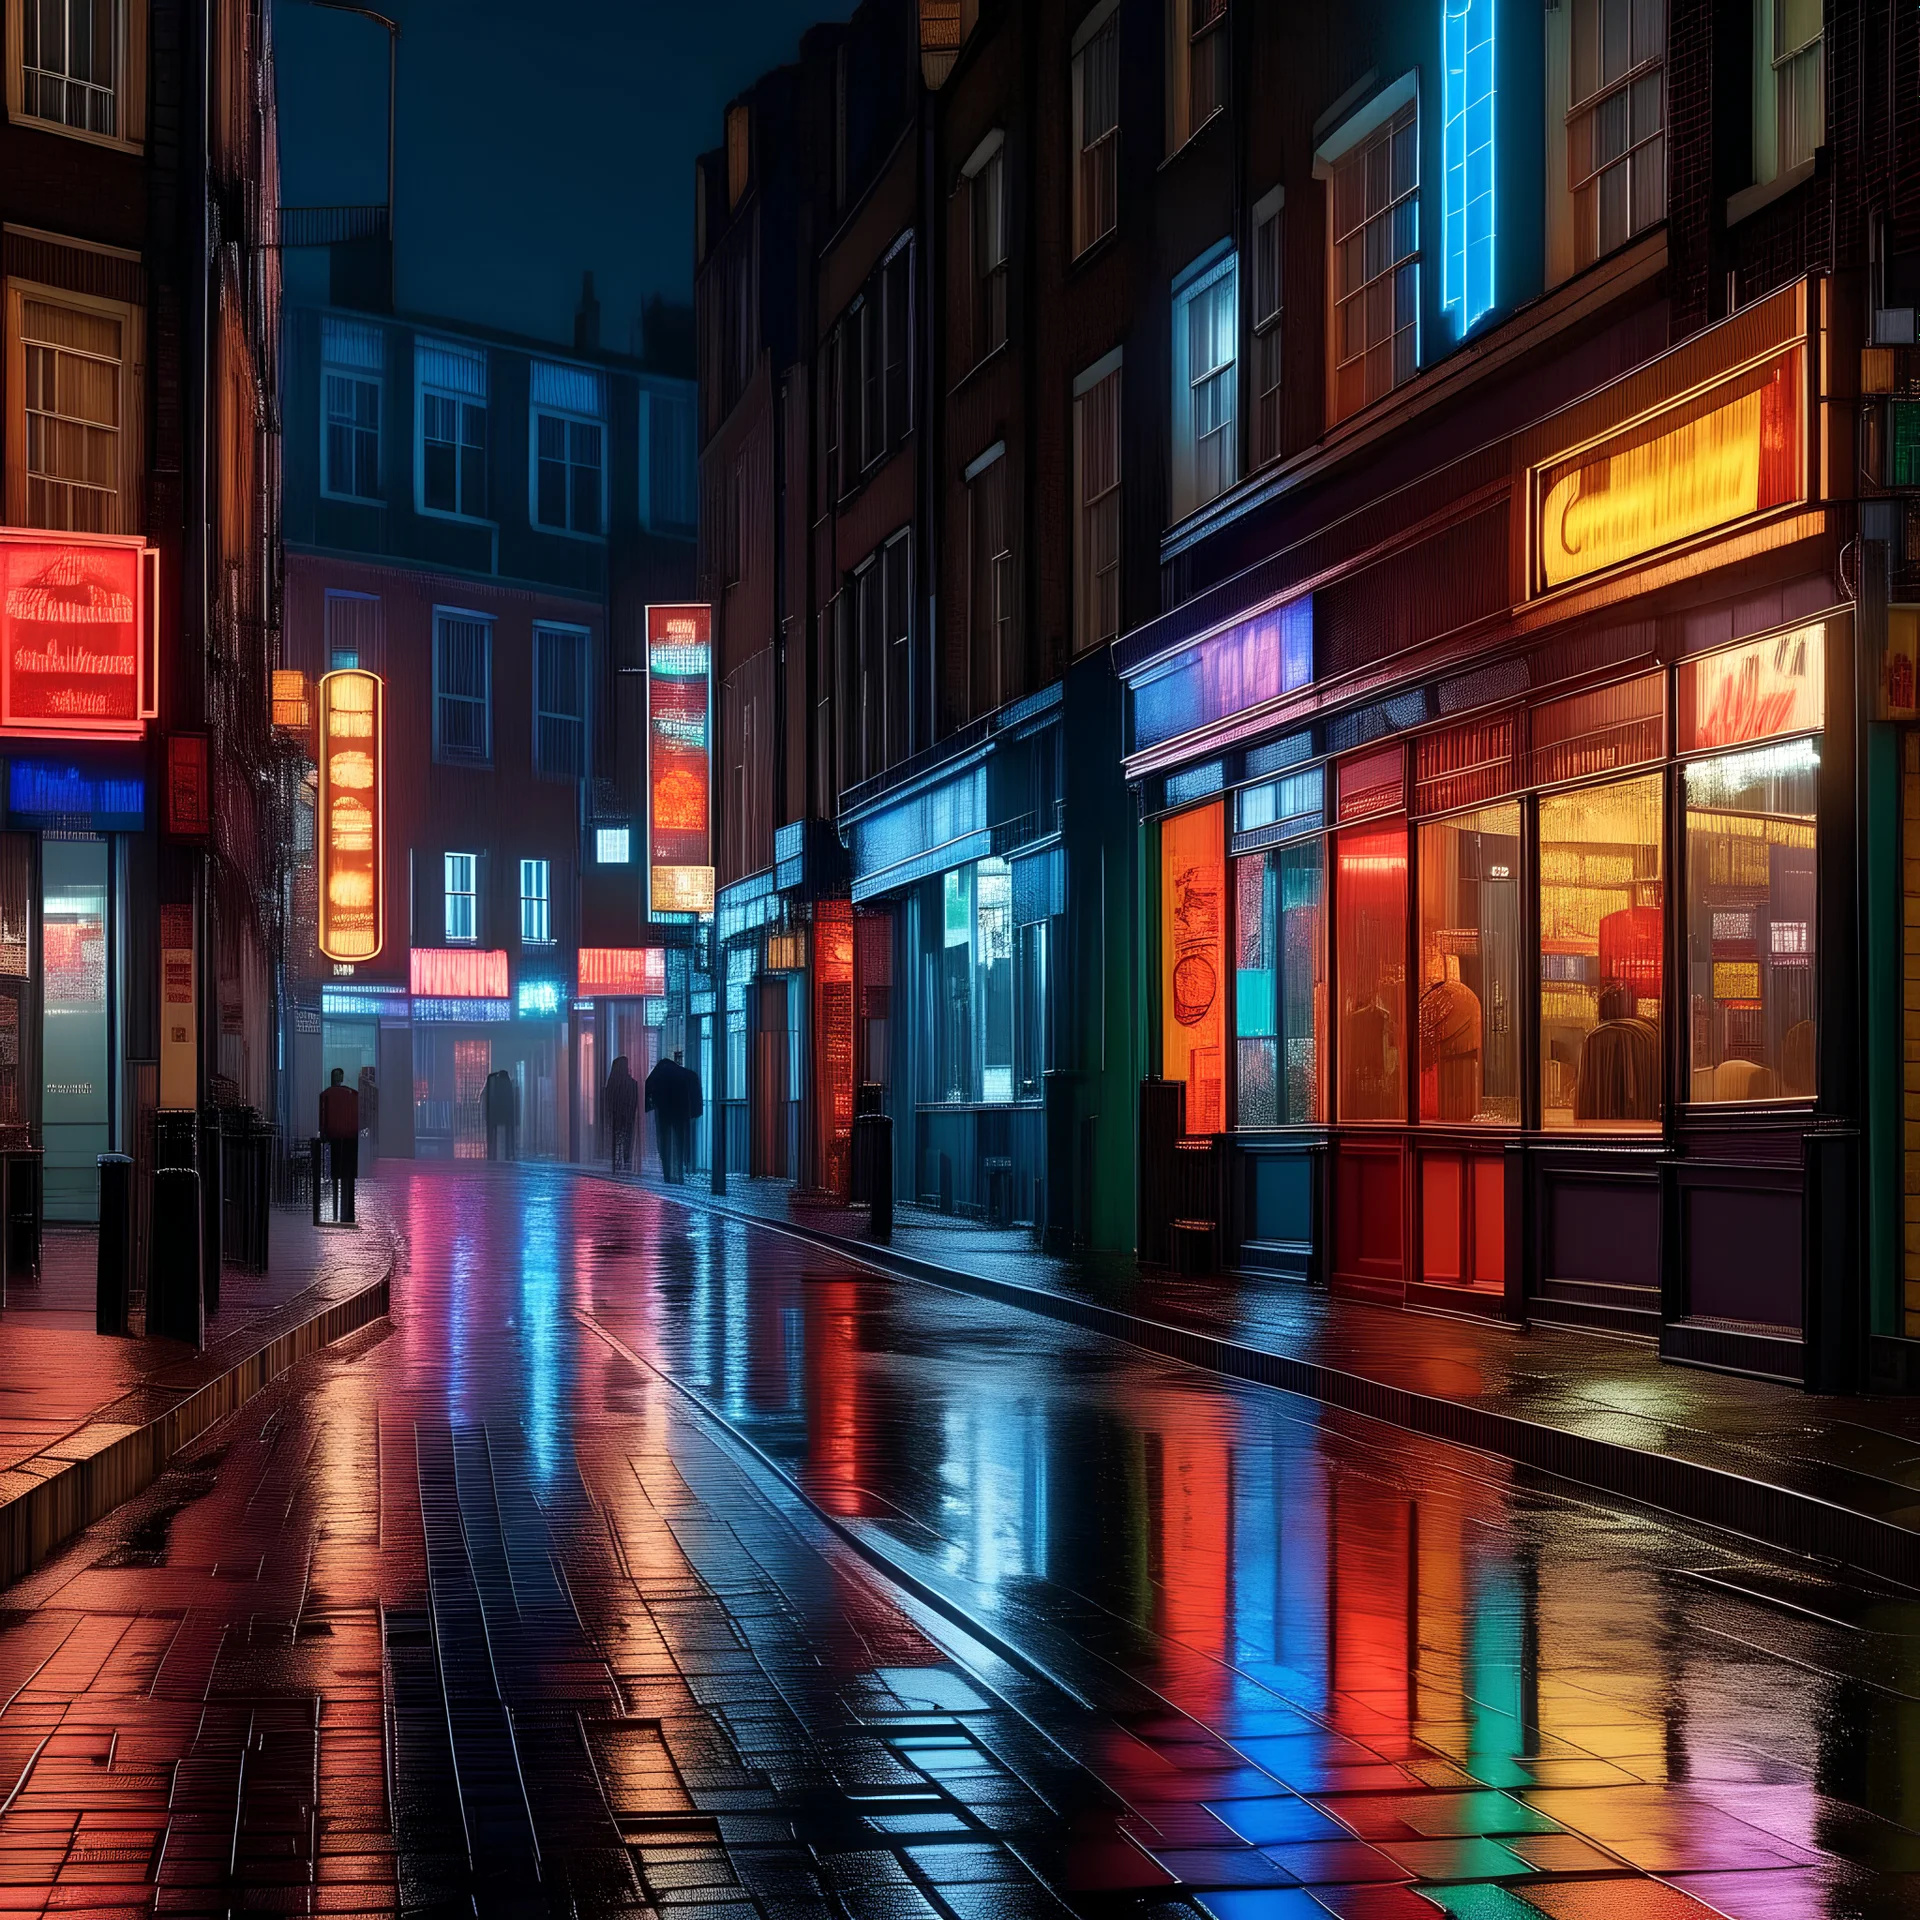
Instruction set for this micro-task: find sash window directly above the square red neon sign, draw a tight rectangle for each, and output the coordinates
[8,280,144,534]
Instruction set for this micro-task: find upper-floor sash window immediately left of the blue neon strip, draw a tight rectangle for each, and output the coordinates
[1329,100,1421,420]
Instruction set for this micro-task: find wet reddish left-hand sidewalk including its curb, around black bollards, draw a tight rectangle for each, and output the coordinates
[0,1183,396,1584]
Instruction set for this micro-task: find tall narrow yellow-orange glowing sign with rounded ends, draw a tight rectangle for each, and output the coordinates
[319,666,386,964]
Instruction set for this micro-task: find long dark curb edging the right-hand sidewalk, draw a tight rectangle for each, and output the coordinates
[591,1175,1920,1586]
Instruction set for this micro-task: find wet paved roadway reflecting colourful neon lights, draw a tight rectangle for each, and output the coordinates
[0,1165,1920,1920]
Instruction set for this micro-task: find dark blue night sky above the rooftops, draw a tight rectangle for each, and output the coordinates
[275,0,852,348]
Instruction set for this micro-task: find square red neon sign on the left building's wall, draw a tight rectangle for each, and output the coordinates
[0,530,159,735]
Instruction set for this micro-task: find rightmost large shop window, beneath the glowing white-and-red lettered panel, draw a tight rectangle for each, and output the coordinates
[1686,739,1820,1100]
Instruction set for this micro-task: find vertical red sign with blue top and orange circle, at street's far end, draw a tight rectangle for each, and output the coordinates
[647,607,714,914]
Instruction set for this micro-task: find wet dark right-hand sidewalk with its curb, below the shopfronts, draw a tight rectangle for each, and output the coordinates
[599,1173,1920,1586]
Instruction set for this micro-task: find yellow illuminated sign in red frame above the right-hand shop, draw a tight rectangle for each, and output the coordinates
[1534,349,1801,589]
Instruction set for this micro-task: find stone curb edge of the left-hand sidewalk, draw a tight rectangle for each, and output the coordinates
[0,1246,394,1586]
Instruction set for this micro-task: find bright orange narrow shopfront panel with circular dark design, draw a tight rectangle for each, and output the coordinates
[1160,801,1227,1135]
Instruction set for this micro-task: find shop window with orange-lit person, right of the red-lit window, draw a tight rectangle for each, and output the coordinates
[1419,801,1521,1125]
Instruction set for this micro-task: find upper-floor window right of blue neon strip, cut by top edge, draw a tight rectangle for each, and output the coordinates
[1567,0,1658,269]
